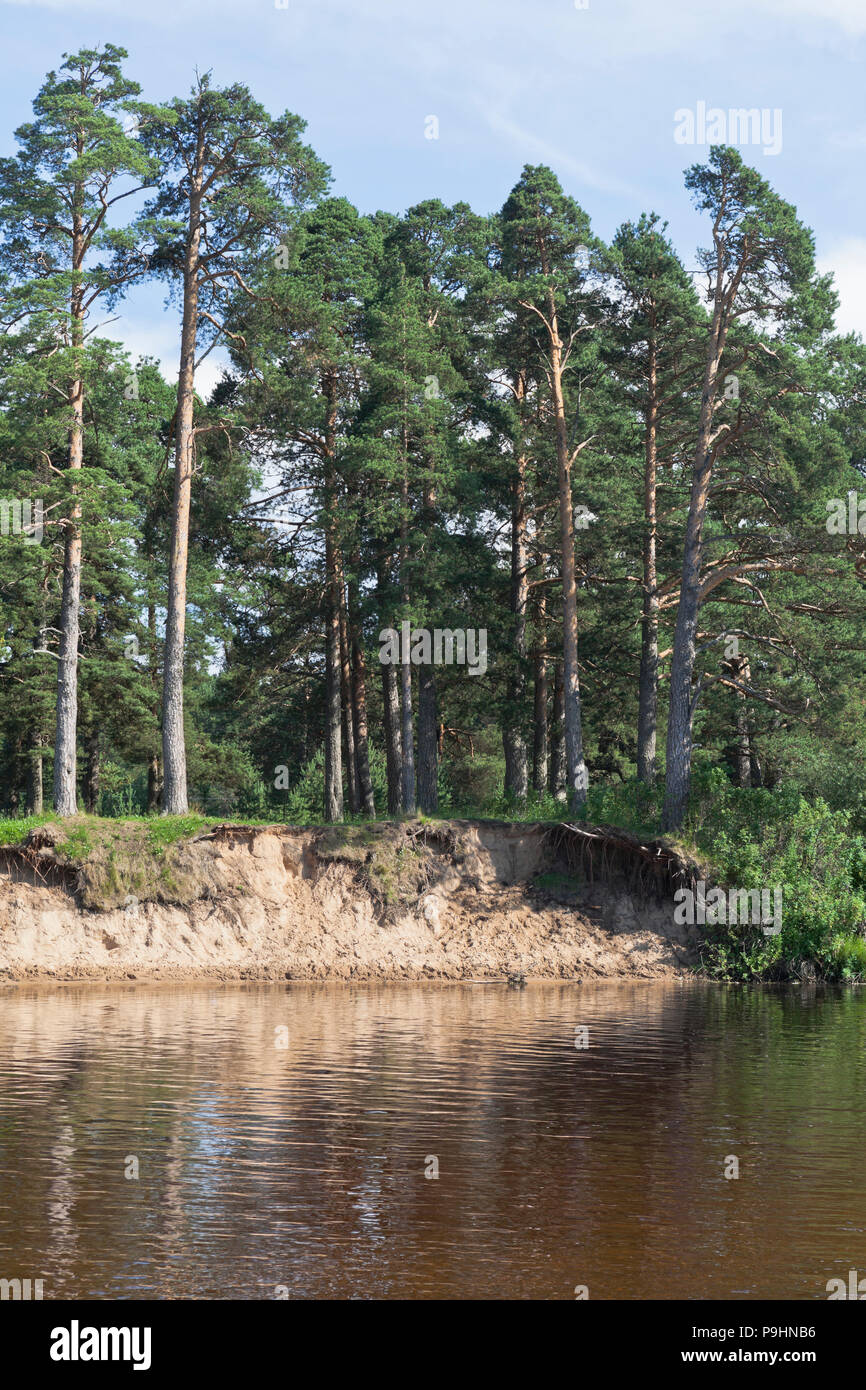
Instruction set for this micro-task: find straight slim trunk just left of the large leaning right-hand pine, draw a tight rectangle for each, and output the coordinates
[638,318,659,787]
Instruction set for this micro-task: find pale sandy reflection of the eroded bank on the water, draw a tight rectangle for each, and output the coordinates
[0,980,714,1088]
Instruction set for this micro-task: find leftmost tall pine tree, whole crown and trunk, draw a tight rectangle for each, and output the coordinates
[0,44,154,816]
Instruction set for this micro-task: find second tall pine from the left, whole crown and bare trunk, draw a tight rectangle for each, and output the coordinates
[139,75,327,815]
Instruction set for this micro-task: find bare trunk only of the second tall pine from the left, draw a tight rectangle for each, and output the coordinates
[163,180,203,816]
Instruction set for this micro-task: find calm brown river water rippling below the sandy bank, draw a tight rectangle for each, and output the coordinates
[0,983,866,1300]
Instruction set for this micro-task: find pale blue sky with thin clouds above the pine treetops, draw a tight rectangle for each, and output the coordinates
[0,0,866,389]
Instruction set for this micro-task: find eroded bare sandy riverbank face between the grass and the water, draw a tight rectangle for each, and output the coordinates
[0,821,699,981]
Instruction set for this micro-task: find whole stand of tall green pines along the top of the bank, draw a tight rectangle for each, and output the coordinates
[0,44,866,973]
